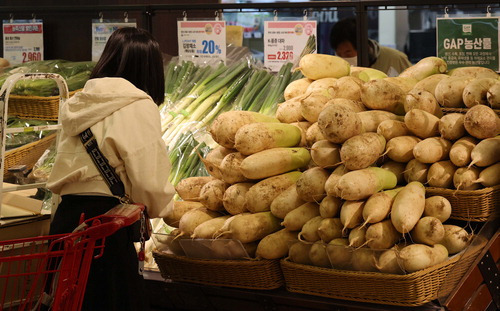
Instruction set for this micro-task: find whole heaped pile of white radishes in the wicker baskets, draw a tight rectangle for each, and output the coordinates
[160,54,500,273]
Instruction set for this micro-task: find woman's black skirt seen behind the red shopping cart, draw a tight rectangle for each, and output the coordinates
[50,195,149,311]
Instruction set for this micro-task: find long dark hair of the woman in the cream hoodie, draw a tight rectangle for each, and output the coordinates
[90,27,165,105]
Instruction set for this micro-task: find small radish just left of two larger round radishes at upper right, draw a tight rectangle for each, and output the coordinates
[405,109,439,138]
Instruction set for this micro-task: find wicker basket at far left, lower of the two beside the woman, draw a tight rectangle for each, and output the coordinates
[3,133,56,178]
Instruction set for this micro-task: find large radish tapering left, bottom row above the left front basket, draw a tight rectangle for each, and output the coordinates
[220,212,281,243]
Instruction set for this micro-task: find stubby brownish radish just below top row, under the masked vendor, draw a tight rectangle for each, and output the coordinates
[361,79,406,114]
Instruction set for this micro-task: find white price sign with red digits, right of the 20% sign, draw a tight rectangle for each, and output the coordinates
[264,21,317,71]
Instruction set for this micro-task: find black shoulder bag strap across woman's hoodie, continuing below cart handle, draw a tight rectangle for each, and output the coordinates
[80,128,151,275]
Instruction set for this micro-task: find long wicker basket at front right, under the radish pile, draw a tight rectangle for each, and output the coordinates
[281,239,485,306]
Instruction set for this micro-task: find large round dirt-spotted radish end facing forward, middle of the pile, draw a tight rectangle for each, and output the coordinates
[317,104,363,144]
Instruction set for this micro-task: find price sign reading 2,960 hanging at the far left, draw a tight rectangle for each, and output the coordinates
[3,19,43,65]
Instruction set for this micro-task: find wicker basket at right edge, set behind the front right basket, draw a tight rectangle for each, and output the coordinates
[425,185,500,221]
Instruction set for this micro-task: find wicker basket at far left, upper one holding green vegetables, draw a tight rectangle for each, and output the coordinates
[9,90,79,121]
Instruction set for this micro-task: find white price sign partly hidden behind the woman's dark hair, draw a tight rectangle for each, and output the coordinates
[92,19,137,62]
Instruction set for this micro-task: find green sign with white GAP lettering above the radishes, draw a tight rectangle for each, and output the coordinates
[436,17,500,71]
